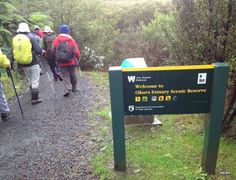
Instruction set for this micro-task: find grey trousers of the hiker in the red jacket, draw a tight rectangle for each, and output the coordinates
[60,66,77,93]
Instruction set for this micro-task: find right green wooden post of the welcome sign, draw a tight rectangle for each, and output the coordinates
[202,63,229,174]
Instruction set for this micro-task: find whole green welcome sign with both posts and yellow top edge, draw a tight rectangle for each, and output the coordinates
[109,63,229,174]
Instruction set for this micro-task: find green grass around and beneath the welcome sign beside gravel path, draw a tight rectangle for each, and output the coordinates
[88,72,236,180]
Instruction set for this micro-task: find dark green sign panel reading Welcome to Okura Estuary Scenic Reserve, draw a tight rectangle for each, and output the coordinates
[123,68,213,115]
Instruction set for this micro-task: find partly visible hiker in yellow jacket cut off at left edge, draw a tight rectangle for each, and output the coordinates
[0,49,11,121]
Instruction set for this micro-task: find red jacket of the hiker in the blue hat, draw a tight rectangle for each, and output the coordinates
[52,34,80,67]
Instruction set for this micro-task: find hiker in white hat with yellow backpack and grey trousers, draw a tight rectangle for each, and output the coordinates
[12,23,44,105]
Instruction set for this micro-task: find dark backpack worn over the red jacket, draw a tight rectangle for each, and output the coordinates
[55,41,74,63]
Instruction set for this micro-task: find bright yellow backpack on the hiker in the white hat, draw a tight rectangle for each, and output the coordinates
[12,34,33,64]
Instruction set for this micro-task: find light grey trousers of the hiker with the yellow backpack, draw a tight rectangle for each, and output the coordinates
[23,64,41,89]
